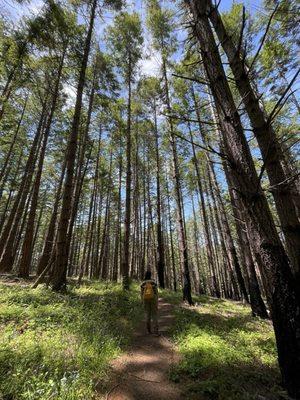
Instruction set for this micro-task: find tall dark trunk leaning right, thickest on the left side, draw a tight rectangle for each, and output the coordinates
[51,0,97,290]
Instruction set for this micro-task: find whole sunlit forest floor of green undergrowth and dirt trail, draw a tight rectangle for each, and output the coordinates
[0,280,285,400]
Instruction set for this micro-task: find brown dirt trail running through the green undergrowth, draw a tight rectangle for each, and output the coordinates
[104,299,183,400]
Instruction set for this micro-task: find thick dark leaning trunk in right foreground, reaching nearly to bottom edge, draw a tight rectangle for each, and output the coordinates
[185,0,300,397]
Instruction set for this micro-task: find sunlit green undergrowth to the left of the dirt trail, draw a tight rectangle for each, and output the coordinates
[0,283,142,400]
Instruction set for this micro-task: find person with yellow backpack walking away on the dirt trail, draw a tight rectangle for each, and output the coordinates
[141,271,160,336]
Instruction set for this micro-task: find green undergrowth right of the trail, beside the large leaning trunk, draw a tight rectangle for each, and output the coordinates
[166,293,282,400]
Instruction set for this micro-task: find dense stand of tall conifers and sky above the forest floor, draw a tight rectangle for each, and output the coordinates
[0,0,300,398]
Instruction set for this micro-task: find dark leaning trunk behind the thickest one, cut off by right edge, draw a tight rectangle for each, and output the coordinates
[207,0,300,285]
